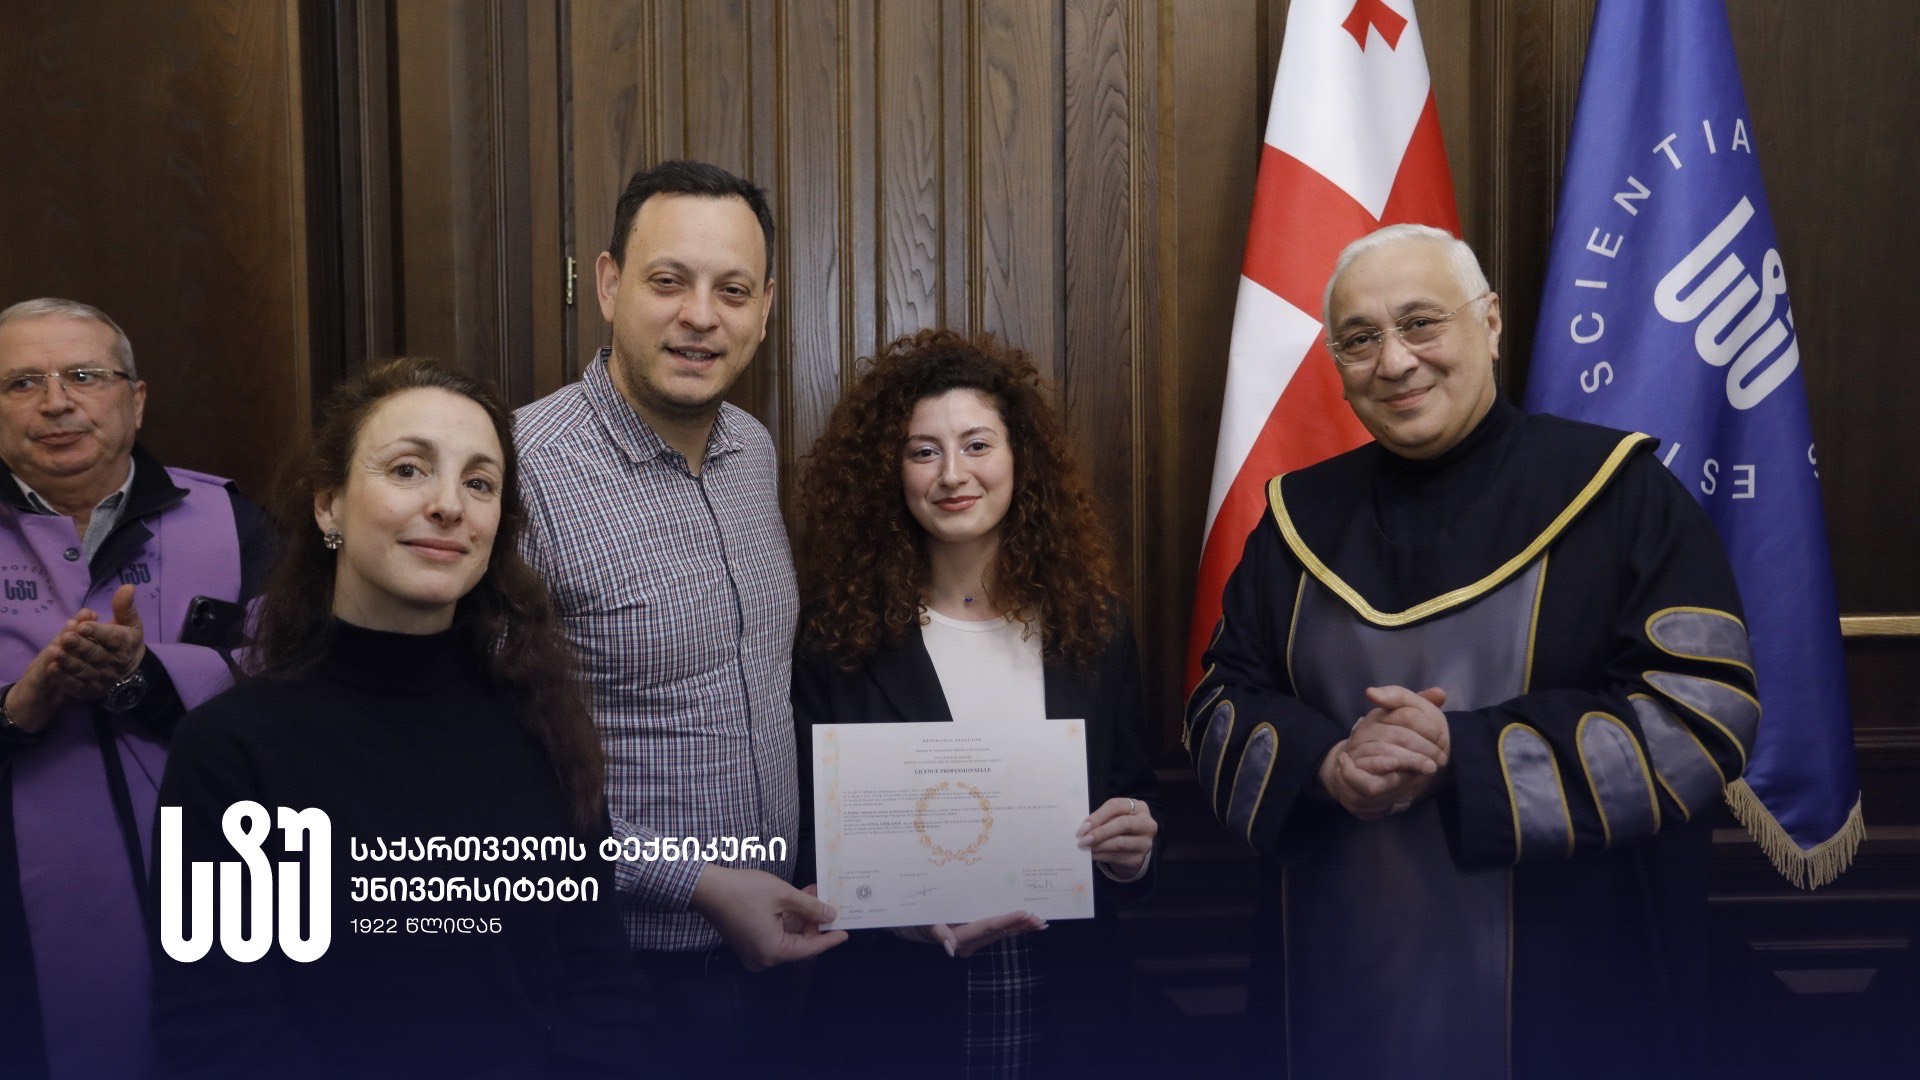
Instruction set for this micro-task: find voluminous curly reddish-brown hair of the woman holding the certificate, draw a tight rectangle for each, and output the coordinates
[795,331,1116,669]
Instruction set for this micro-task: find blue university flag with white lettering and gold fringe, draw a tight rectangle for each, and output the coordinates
[1526,0,1864,888]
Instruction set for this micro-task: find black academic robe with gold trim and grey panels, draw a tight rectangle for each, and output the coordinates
[1187,402,1759,1078]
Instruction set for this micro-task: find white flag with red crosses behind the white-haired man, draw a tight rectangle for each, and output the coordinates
[1187,0,1459,686]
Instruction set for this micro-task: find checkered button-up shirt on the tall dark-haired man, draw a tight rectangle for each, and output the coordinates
[515,350,799,951]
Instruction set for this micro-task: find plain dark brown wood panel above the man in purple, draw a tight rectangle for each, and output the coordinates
[0,0,309,494]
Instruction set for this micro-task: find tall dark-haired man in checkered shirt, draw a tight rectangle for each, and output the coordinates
[515,161,847,1049]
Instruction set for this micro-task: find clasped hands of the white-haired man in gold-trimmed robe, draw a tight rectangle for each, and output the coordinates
[1319,686,1452,821]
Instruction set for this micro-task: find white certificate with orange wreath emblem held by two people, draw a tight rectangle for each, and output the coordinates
[814,721,1092,930]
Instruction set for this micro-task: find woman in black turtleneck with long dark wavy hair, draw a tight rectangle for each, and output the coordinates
[154,359,643,1078]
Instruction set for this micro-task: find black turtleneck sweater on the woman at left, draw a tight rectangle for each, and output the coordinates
[154,621,643,1078]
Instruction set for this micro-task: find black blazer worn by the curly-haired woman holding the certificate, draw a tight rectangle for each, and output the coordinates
[793,615,1160,1076]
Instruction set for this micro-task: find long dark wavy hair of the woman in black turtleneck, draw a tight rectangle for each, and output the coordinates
[246,357,605,830]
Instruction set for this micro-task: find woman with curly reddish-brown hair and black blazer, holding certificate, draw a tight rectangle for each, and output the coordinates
[793,331,1158,1076]
